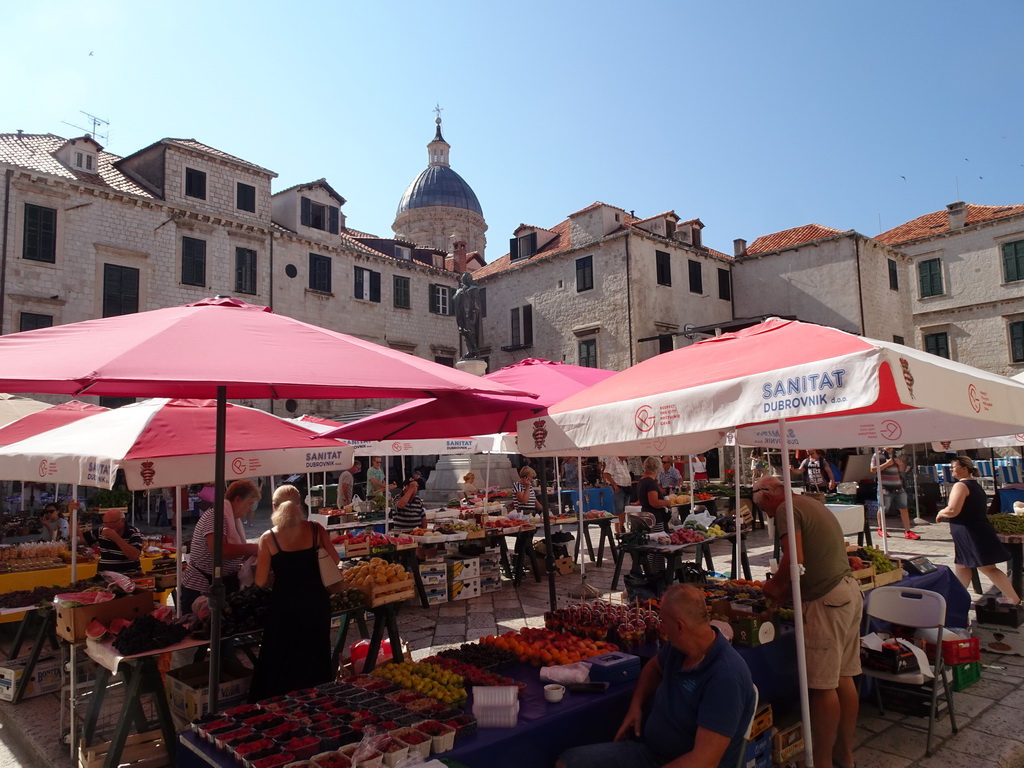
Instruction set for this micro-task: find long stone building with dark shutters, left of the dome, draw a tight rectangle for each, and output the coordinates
[0,132,459,415]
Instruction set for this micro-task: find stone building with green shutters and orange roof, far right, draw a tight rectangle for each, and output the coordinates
[877,202,1024,376]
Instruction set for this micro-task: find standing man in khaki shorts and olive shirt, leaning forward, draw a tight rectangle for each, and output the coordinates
[754,477,863,768]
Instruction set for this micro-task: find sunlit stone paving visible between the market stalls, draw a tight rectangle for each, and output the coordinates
[0,511,1024,768]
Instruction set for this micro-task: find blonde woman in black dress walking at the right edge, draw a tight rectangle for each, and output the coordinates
[935,456,1020,604]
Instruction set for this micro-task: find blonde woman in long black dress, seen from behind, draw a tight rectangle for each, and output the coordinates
[249,501,339,701]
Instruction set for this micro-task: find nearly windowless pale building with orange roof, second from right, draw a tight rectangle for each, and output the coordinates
[732,224,913,345]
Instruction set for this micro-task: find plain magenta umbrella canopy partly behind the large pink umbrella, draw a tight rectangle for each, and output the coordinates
[327,358,613,442]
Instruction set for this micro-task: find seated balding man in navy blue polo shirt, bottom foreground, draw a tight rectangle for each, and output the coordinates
[556,584,754,768]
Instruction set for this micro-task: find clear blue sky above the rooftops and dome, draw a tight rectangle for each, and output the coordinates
[0,0,1024,260]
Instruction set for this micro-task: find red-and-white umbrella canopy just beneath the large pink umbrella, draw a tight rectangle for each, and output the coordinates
[0,398,352,490]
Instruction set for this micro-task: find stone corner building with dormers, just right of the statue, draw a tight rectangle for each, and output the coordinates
[474,203,732,371]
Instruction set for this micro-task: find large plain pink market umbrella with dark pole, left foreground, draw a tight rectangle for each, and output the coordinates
[0,297,530,709]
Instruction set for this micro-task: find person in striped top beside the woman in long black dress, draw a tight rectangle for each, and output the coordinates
[181,480,259,613]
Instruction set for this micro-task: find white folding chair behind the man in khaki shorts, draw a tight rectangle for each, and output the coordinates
[863,587,956,757]
